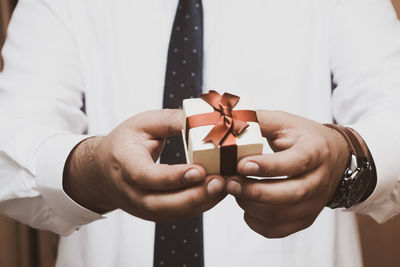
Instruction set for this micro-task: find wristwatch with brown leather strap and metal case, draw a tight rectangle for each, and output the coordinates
[324,124,376,209]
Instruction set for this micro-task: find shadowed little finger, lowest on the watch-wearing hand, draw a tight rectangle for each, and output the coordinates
[244,213,316,238]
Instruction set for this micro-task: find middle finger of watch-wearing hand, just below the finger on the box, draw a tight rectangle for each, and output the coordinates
[226,169,325,206]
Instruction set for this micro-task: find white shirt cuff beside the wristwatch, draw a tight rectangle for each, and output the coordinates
[349,119,400,223]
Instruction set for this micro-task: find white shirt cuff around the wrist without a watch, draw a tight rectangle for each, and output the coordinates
[36,134,104,234]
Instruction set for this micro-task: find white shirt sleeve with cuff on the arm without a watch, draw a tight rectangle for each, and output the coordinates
[0,0,102,235]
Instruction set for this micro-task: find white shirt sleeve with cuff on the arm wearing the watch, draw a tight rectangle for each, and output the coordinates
[330,0,400,222]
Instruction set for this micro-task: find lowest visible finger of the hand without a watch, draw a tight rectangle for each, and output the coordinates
[132,176,226,222]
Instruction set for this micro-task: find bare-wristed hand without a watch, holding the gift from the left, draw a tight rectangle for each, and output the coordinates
[63,110,225,222]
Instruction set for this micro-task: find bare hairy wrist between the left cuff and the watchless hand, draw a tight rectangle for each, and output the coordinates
[63,137,115,213]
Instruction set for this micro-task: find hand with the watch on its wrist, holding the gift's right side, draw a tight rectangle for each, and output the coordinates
[227,111,350,238]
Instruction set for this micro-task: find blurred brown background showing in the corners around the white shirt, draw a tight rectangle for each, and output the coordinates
[0,0,400,267]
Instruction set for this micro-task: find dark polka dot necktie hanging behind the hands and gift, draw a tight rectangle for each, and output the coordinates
[154,0,204,267]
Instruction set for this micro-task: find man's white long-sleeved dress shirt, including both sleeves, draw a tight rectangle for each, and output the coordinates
[0,0,400,267]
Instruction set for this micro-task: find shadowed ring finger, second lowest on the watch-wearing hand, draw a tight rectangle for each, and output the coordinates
[236,198,322,224]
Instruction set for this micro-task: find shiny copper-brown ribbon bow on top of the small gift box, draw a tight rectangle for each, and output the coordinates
[200,90,249,147]
